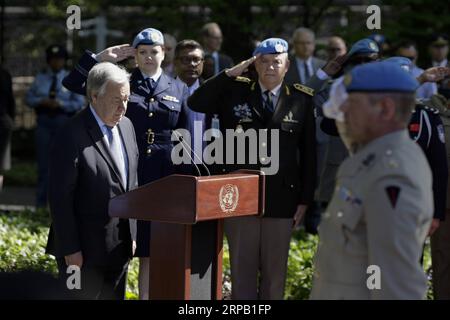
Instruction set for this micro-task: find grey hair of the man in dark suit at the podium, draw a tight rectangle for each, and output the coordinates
[86,62,130,102]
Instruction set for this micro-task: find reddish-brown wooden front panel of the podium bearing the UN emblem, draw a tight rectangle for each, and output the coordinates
[196,174,259,221]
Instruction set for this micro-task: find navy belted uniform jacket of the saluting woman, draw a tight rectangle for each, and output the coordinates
[63,51,188,185]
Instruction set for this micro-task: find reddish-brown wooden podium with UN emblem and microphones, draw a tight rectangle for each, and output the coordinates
[109,170,265,300]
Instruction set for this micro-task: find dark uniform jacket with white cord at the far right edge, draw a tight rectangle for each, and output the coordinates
[408,104,448,220]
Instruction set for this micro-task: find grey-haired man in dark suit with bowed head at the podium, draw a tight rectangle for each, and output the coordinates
[47,62,138,299]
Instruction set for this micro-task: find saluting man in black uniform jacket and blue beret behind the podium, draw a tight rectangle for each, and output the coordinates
[188,38,316,299]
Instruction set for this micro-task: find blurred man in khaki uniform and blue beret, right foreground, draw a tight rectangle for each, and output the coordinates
[311,62,433,299]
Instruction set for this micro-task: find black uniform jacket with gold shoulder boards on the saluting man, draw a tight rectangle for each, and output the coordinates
[188,72,316,218]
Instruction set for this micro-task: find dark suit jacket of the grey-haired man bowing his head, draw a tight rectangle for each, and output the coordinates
[47,108,139,266]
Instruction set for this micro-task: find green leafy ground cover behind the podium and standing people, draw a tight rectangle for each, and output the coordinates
[0,210,433,300]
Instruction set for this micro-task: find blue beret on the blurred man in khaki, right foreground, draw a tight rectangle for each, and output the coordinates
[344,61,419,92]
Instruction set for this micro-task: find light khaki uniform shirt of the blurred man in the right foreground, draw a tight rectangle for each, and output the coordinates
[311,130,433,299]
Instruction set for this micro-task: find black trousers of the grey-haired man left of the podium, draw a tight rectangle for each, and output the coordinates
[57,258,129,300]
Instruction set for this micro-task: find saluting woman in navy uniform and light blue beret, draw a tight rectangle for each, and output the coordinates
[63,28,188,299]
